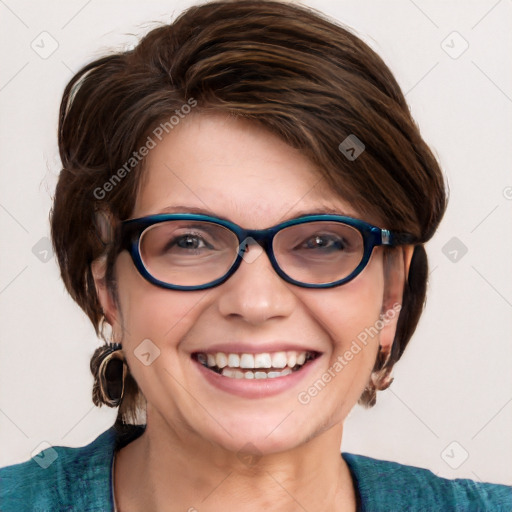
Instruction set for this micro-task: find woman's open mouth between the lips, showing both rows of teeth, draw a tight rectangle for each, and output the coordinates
[192,350,320,379]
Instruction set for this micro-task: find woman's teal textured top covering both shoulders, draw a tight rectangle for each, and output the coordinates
[0,427,512,512]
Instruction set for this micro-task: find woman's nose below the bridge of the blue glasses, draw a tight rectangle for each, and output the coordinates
[218,243,297,325]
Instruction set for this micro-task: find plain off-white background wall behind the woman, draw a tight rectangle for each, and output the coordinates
[0,0,512,484]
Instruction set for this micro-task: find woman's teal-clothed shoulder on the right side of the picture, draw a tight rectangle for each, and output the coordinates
[343,453,512,512]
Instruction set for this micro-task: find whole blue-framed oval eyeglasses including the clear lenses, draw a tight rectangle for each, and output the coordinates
[121,213,414,291]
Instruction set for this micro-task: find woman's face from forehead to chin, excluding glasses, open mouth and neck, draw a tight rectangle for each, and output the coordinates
[98,114,398,453]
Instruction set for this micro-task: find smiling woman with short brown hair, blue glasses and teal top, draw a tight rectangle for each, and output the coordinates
[0,1,512,512]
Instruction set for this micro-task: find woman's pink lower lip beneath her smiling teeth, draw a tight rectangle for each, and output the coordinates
[192,356,321,398]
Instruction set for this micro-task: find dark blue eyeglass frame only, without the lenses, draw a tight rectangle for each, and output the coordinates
[121,213,415,291]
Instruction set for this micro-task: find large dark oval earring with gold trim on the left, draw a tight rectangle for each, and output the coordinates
[97,343,126,407]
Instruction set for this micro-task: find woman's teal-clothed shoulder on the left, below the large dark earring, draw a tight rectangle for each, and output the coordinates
[0,428,116,512]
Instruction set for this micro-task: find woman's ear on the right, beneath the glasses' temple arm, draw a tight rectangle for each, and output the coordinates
[380,245,414,360]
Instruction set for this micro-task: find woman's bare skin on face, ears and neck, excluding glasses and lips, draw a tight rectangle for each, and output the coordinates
[93,114,411,512]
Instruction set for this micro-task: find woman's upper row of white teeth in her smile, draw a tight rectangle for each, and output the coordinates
[197,350,308,368]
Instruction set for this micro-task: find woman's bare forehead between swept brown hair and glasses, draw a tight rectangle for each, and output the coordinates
[133,114,357,228]
